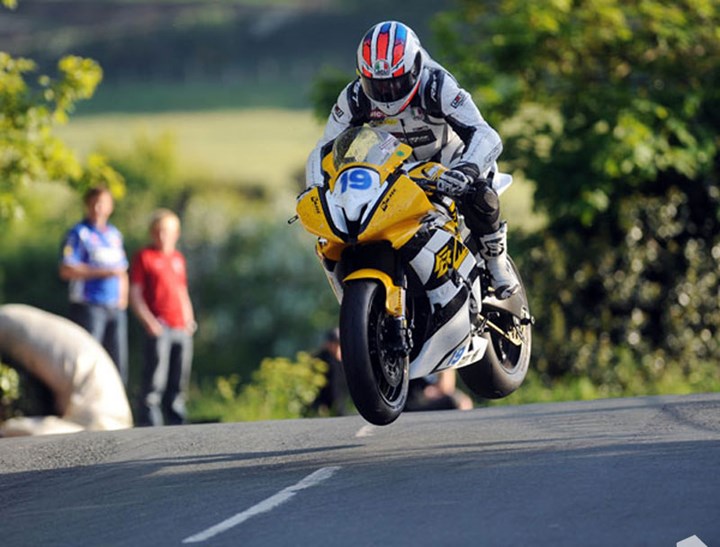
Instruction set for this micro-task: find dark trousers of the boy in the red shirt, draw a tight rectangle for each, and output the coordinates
[136,328,193,426]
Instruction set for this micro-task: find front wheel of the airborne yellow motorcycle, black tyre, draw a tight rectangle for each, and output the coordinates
[340,279,409,425]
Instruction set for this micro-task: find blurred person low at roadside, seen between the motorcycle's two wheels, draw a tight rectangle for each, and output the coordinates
[405,369,473,412]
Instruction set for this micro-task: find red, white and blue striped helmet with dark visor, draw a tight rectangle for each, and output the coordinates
[357,21,423,116]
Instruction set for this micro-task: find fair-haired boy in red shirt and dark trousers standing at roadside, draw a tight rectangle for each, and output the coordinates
[130,209,197,426]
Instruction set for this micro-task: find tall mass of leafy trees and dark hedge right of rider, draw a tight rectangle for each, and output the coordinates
[438,0,720,390]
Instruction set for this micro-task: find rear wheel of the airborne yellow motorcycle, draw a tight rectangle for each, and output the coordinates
[458,257,532,399]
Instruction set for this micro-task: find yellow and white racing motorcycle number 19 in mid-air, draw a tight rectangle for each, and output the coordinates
[296,127,534,425]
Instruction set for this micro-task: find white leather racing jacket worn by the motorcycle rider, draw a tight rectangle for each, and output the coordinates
[306,56,502,186]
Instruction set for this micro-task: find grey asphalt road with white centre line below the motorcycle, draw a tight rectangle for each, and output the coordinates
[0,394,720,547]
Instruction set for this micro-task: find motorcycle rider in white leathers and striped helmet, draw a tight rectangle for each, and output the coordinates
[306,21,519,299]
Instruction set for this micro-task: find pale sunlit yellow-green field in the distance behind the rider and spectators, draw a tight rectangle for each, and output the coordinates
[59,109,542,231]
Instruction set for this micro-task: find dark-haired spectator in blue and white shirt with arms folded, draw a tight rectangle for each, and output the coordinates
[59,186,128,385]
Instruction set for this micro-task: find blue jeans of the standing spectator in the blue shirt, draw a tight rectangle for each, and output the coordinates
[70,303,128,386]
